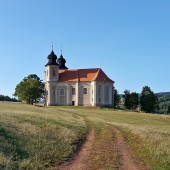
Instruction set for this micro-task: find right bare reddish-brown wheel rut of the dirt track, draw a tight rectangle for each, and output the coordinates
[113,128,148,170]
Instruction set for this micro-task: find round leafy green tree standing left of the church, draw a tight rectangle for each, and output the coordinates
[14,74,44,104]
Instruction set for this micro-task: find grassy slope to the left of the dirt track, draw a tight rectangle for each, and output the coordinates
[0,103,87,169]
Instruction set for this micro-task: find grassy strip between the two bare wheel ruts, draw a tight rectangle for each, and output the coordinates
[87,123,118,170]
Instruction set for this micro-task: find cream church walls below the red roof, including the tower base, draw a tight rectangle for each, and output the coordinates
[45,81,113,106]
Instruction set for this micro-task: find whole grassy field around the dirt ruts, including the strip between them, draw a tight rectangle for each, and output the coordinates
[0,102,170,170]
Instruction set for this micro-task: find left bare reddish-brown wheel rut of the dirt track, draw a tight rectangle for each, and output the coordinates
[59,128,94,170]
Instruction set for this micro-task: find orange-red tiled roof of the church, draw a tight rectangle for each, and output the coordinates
[59,68,114,82]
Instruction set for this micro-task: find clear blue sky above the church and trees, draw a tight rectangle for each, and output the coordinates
[0,0,170,96]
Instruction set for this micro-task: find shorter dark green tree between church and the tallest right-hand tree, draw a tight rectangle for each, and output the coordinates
[123,90,139,110]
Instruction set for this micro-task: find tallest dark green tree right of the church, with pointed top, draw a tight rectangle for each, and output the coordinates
[140,86,159,113]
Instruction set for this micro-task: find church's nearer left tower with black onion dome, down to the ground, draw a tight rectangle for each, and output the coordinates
[44,46,59,106]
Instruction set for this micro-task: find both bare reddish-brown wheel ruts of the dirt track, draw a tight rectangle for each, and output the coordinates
[59,128,148,170]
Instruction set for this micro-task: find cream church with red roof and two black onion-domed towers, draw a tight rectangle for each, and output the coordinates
[44,47,114,106]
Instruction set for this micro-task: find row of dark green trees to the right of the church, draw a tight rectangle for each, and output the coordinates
[114,86,170,114]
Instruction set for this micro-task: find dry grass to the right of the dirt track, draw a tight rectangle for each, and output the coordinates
[74,109,170,170]
